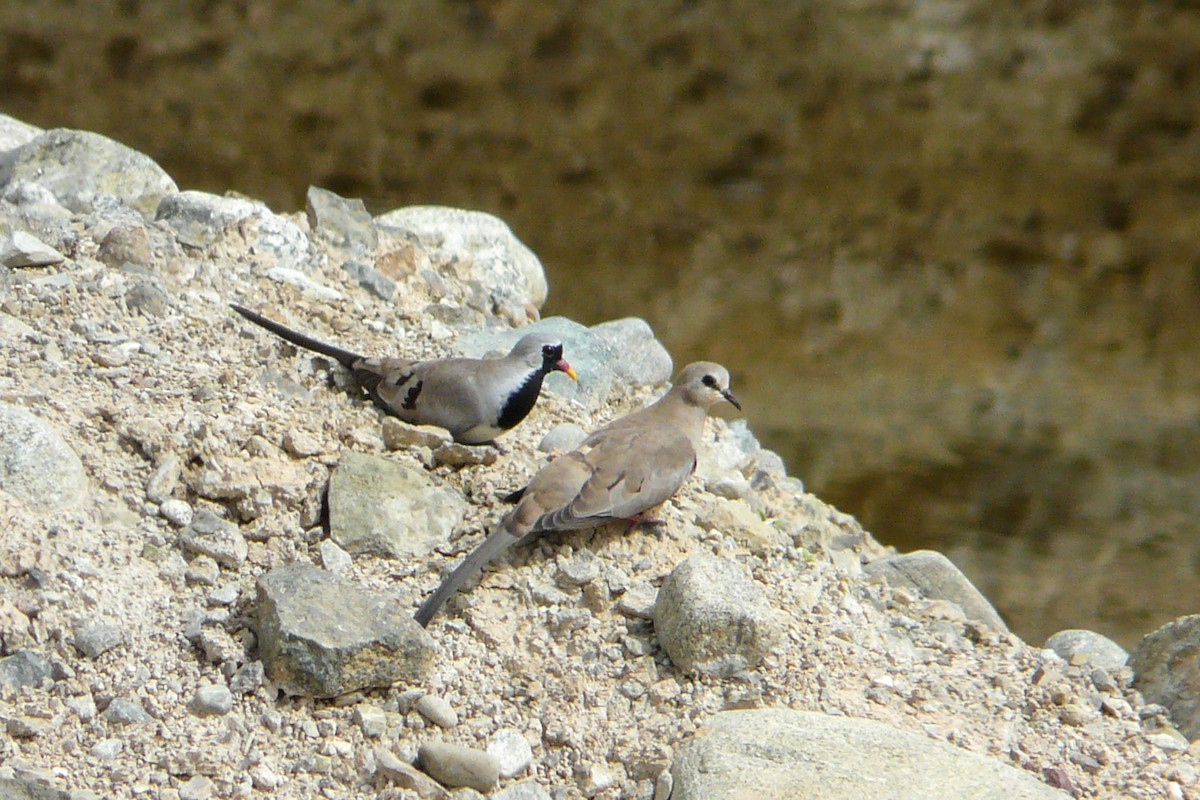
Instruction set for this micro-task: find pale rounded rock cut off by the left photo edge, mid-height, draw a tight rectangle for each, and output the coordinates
[0,403,88,511]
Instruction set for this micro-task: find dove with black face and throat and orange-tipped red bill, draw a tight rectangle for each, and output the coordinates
[230,303,576,445]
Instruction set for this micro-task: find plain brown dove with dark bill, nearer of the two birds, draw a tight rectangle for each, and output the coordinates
[416,361,742,625]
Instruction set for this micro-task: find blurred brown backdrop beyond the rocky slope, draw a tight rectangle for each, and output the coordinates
[0,0,1200,645]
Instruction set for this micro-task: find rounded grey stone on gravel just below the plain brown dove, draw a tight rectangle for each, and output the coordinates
[654,555,776,675]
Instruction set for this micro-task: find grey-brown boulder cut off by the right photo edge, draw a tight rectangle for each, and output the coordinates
[1128,614,1200,740]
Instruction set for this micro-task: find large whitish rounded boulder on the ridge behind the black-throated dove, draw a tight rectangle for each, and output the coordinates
[376,205,550,323]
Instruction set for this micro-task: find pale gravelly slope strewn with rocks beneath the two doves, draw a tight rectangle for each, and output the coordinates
[0,118,1200,800]
